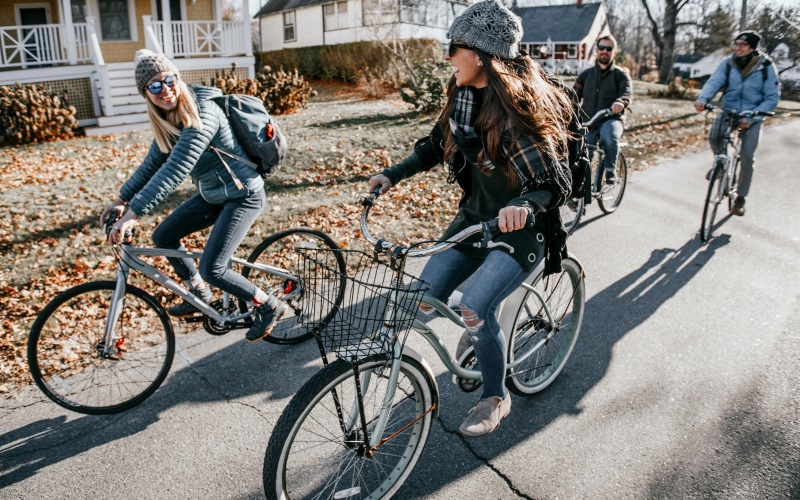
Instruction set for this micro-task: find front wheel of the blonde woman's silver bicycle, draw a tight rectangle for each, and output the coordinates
[28,281,175,415]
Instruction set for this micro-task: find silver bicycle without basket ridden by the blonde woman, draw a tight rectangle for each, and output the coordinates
[28,212,345,414]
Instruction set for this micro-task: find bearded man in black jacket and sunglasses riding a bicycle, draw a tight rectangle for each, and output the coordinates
[575,35,633,184]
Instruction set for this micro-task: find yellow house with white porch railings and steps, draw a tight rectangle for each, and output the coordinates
[0,0,255,135]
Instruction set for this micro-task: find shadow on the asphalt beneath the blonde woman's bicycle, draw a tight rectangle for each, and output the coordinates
[0,329,320,488]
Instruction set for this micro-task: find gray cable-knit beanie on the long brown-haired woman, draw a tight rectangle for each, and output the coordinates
[447,0,522,59]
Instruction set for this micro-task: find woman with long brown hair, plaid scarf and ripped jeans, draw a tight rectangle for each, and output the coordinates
[370,0,573,437]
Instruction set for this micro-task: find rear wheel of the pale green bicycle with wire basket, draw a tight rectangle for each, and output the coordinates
[506,258,586,396]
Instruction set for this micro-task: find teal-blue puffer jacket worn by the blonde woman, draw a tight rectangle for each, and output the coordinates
[120,85,264,216]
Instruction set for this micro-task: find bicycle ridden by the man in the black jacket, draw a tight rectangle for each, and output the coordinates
[560,108,628,234]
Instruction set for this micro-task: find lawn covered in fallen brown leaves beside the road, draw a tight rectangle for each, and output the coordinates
[0,88,796,395]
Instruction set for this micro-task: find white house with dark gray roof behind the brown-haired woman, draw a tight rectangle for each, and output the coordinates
[513,0,610,75]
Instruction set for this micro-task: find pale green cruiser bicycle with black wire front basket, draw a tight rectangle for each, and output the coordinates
[264,192,585,499]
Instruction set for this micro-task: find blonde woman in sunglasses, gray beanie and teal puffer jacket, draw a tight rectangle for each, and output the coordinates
[100,50,286,341]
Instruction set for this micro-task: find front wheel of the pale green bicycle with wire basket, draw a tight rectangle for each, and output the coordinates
[263,355,437,499]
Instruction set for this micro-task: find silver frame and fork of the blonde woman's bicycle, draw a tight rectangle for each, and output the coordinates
[103,243,302,357]
